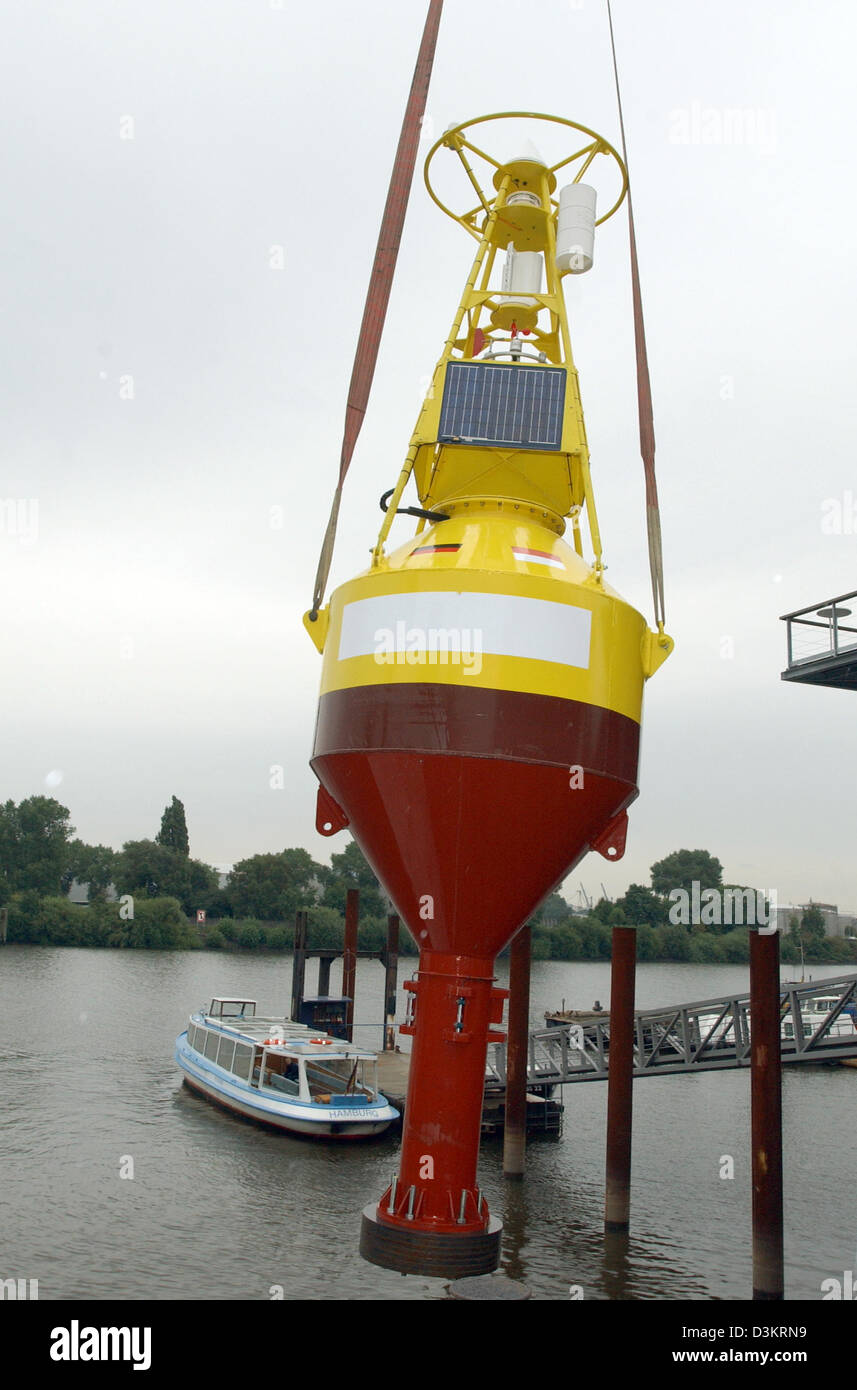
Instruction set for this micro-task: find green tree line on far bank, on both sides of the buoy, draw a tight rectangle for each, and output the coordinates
[0,796,856,963]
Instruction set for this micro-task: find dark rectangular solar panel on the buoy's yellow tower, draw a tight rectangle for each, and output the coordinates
[438,361,565,449]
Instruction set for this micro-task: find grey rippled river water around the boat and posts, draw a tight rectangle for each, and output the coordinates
[0,945,857,1300]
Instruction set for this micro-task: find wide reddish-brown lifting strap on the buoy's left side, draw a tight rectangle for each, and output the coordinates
[310,0,443,621]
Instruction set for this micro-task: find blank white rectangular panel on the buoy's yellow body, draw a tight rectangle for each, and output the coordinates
[339,589,592,670]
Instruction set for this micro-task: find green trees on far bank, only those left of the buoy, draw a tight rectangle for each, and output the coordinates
[0,796,415,952]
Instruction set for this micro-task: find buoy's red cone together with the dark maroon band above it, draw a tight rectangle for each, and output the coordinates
[313,684,639,958]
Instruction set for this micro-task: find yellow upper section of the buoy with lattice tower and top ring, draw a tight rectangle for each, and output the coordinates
[304,113,672,695]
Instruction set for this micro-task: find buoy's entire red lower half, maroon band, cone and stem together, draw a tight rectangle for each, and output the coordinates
[313,684,639,1275]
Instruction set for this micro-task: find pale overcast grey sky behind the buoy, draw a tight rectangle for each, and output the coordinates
[0,0,857,910]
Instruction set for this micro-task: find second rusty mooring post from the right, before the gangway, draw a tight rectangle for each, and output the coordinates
[604,927,636,1230]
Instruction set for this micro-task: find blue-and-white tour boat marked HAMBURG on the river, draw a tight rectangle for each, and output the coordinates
[175,998,399,1138]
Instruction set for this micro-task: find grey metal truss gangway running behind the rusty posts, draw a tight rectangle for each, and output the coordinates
[485,974,857,1093]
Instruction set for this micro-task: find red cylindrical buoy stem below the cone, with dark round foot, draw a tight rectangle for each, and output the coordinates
[360,951,508,1277]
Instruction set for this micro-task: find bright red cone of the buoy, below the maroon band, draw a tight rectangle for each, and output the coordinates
[313,752,636,958]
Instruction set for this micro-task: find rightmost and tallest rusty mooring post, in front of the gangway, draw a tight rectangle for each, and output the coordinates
[750,930,783,1300]
